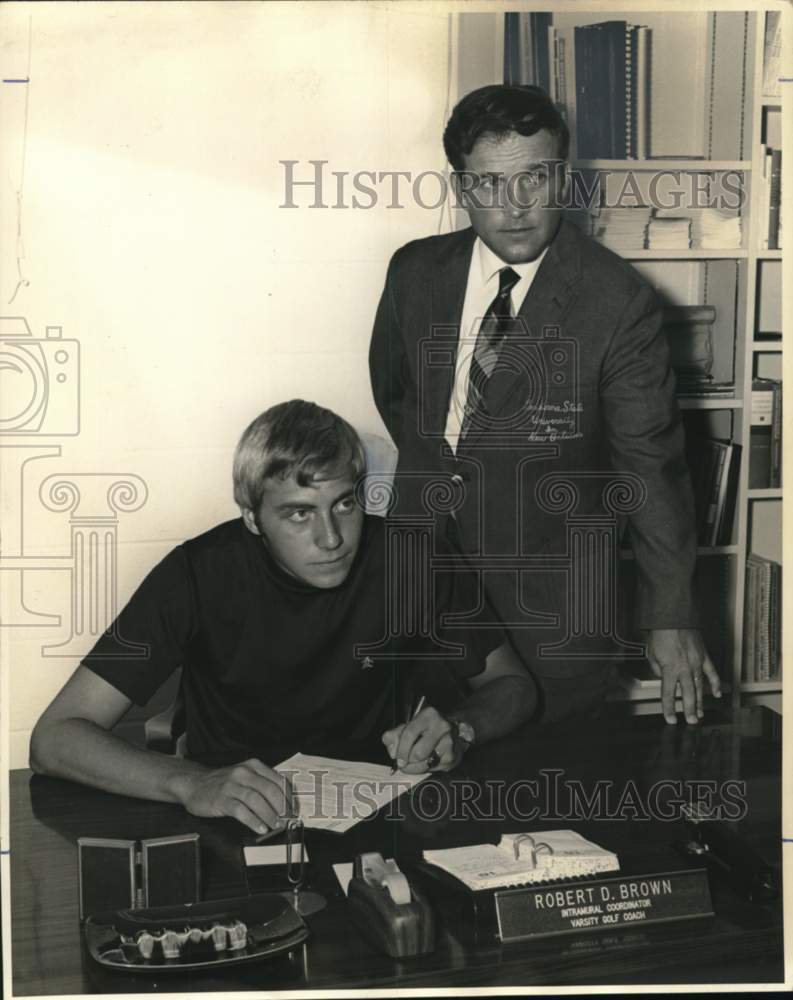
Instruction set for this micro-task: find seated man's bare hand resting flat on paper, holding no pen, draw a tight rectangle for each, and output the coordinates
[175,758,295,834]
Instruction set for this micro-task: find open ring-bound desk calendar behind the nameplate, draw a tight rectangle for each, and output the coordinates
[423,830,619,891]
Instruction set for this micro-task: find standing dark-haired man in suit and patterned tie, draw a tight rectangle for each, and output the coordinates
[369,85,720,724]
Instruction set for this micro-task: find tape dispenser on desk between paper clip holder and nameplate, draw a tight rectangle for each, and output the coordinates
[347,853,435,958]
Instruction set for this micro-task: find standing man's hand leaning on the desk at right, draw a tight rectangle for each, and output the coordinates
[647,628,721,726]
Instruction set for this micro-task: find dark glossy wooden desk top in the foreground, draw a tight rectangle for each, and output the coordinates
[10,708,783,996]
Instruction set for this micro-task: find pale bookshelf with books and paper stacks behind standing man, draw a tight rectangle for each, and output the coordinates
[453,2,789,713]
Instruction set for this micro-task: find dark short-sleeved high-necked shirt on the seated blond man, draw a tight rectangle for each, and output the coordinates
[83,516,503,765]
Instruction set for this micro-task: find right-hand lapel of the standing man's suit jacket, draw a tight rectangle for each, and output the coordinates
[466,220,581,454]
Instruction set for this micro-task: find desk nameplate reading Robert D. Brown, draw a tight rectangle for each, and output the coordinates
[495,868,713,942]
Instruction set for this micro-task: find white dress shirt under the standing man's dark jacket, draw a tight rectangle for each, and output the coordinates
[444,236,548,452]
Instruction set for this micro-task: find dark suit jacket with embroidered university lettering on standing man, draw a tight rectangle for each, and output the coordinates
[370,221,696,672]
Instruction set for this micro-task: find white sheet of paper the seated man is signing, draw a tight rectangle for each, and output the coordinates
[276,753,429,833]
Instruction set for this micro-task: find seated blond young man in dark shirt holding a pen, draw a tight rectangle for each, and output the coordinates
[30,400,535,833]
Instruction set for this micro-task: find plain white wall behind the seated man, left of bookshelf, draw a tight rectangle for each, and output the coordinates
[0,3,449,767]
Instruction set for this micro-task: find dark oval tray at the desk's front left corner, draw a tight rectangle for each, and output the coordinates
[84,893,309,973]
